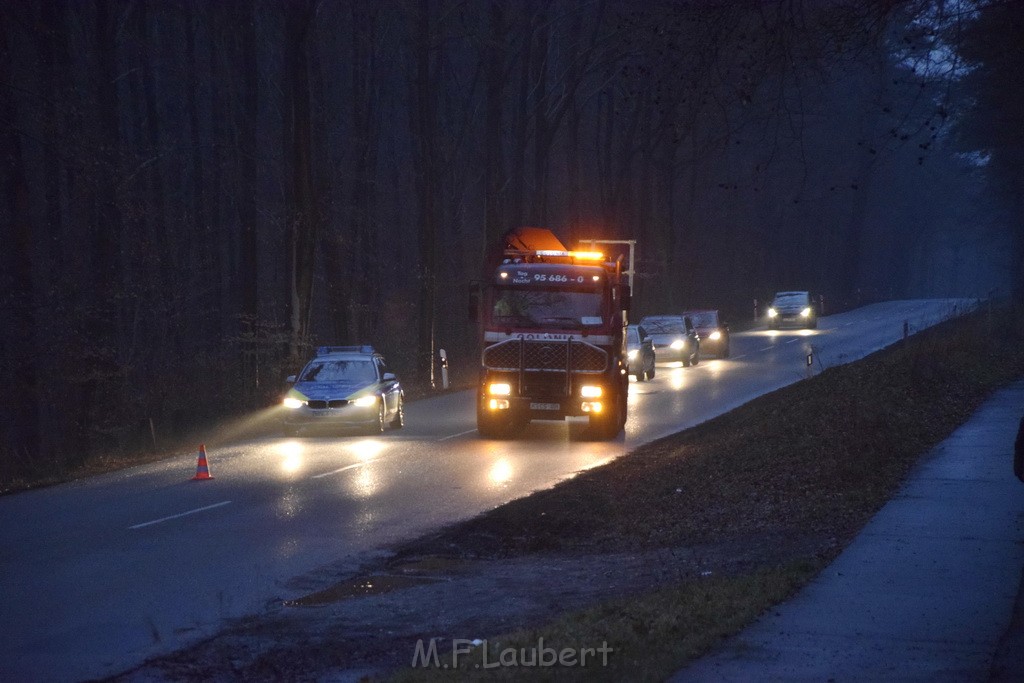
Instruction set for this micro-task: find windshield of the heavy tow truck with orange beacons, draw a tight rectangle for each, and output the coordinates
[490,289,603,328]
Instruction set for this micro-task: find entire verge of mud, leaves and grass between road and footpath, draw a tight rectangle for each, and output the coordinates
[121,311,1024,680]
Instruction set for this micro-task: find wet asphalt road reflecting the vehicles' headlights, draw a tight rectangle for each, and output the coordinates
[0,300,968,680]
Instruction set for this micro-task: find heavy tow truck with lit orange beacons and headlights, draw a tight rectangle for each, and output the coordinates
[471,227,631,439]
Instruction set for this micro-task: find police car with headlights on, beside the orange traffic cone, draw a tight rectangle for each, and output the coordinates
[282,346,406,436]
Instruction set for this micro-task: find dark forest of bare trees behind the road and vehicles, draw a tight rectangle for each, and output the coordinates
[0,0,1024,478]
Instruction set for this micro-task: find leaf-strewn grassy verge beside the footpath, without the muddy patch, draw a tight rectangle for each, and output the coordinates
[389,310,1024,680]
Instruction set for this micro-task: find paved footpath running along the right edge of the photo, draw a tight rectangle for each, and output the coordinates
[672,382,1024,683]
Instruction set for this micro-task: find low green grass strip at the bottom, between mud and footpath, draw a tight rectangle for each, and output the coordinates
[393,560,822,682]
